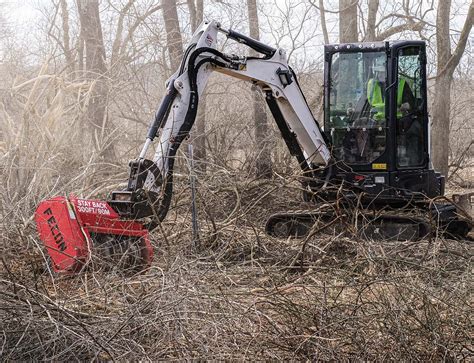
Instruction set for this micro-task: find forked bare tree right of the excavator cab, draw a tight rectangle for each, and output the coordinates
[431,0,474,175]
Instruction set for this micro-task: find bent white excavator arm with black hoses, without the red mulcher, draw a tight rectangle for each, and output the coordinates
[109,21,330,225]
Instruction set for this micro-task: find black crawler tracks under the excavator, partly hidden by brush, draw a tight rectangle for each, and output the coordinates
[265,193,474,241]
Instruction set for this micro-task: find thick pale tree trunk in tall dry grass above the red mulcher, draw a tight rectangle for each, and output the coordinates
[77,0,115,162]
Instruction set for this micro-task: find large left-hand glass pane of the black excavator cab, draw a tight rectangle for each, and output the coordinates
[326,52,386,164]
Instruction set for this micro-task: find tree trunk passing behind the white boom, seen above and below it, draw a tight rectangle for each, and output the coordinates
[247,0,272,178]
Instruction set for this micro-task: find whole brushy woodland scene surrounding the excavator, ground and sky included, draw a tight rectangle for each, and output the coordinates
[0,0,474,360]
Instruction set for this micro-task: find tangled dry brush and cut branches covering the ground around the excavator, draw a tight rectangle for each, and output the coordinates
[0,132,473,361]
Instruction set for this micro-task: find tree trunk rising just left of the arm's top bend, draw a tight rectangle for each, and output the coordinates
[162,0,183,73]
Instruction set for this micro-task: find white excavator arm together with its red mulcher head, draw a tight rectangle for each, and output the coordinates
[35,22,330,274]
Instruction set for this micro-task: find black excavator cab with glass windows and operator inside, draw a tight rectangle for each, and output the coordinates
[324,41,444,198]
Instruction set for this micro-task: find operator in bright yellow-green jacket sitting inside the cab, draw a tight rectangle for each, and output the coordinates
[367,64,415,122]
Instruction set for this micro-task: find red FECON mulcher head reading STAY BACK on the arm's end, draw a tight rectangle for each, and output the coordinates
[35,196,153,274]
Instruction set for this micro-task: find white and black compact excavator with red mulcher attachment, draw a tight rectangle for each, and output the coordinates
[35,21,472,274]
